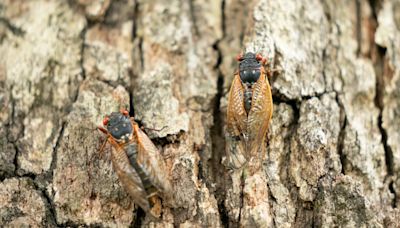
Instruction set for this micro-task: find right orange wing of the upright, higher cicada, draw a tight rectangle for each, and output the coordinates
[247,71,273,157]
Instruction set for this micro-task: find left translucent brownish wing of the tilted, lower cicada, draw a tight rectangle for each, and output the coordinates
[111,145,150,212]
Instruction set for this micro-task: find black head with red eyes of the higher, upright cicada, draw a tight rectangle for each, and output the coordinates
[237,52,266,84]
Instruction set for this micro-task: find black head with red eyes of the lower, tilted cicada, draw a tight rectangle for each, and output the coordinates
[103,110,133,142]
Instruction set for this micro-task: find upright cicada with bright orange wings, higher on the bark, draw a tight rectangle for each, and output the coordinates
[226,52,273,169]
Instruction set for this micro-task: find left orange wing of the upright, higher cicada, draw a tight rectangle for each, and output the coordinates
[226,74,248,169]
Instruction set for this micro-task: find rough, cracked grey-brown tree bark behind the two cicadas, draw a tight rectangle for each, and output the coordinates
[0,0,400,227]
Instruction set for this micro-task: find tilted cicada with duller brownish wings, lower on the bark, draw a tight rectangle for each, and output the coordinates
[99,110,171,217]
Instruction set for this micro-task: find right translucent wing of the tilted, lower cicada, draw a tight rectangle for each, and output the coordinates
[134,125,172,202]
